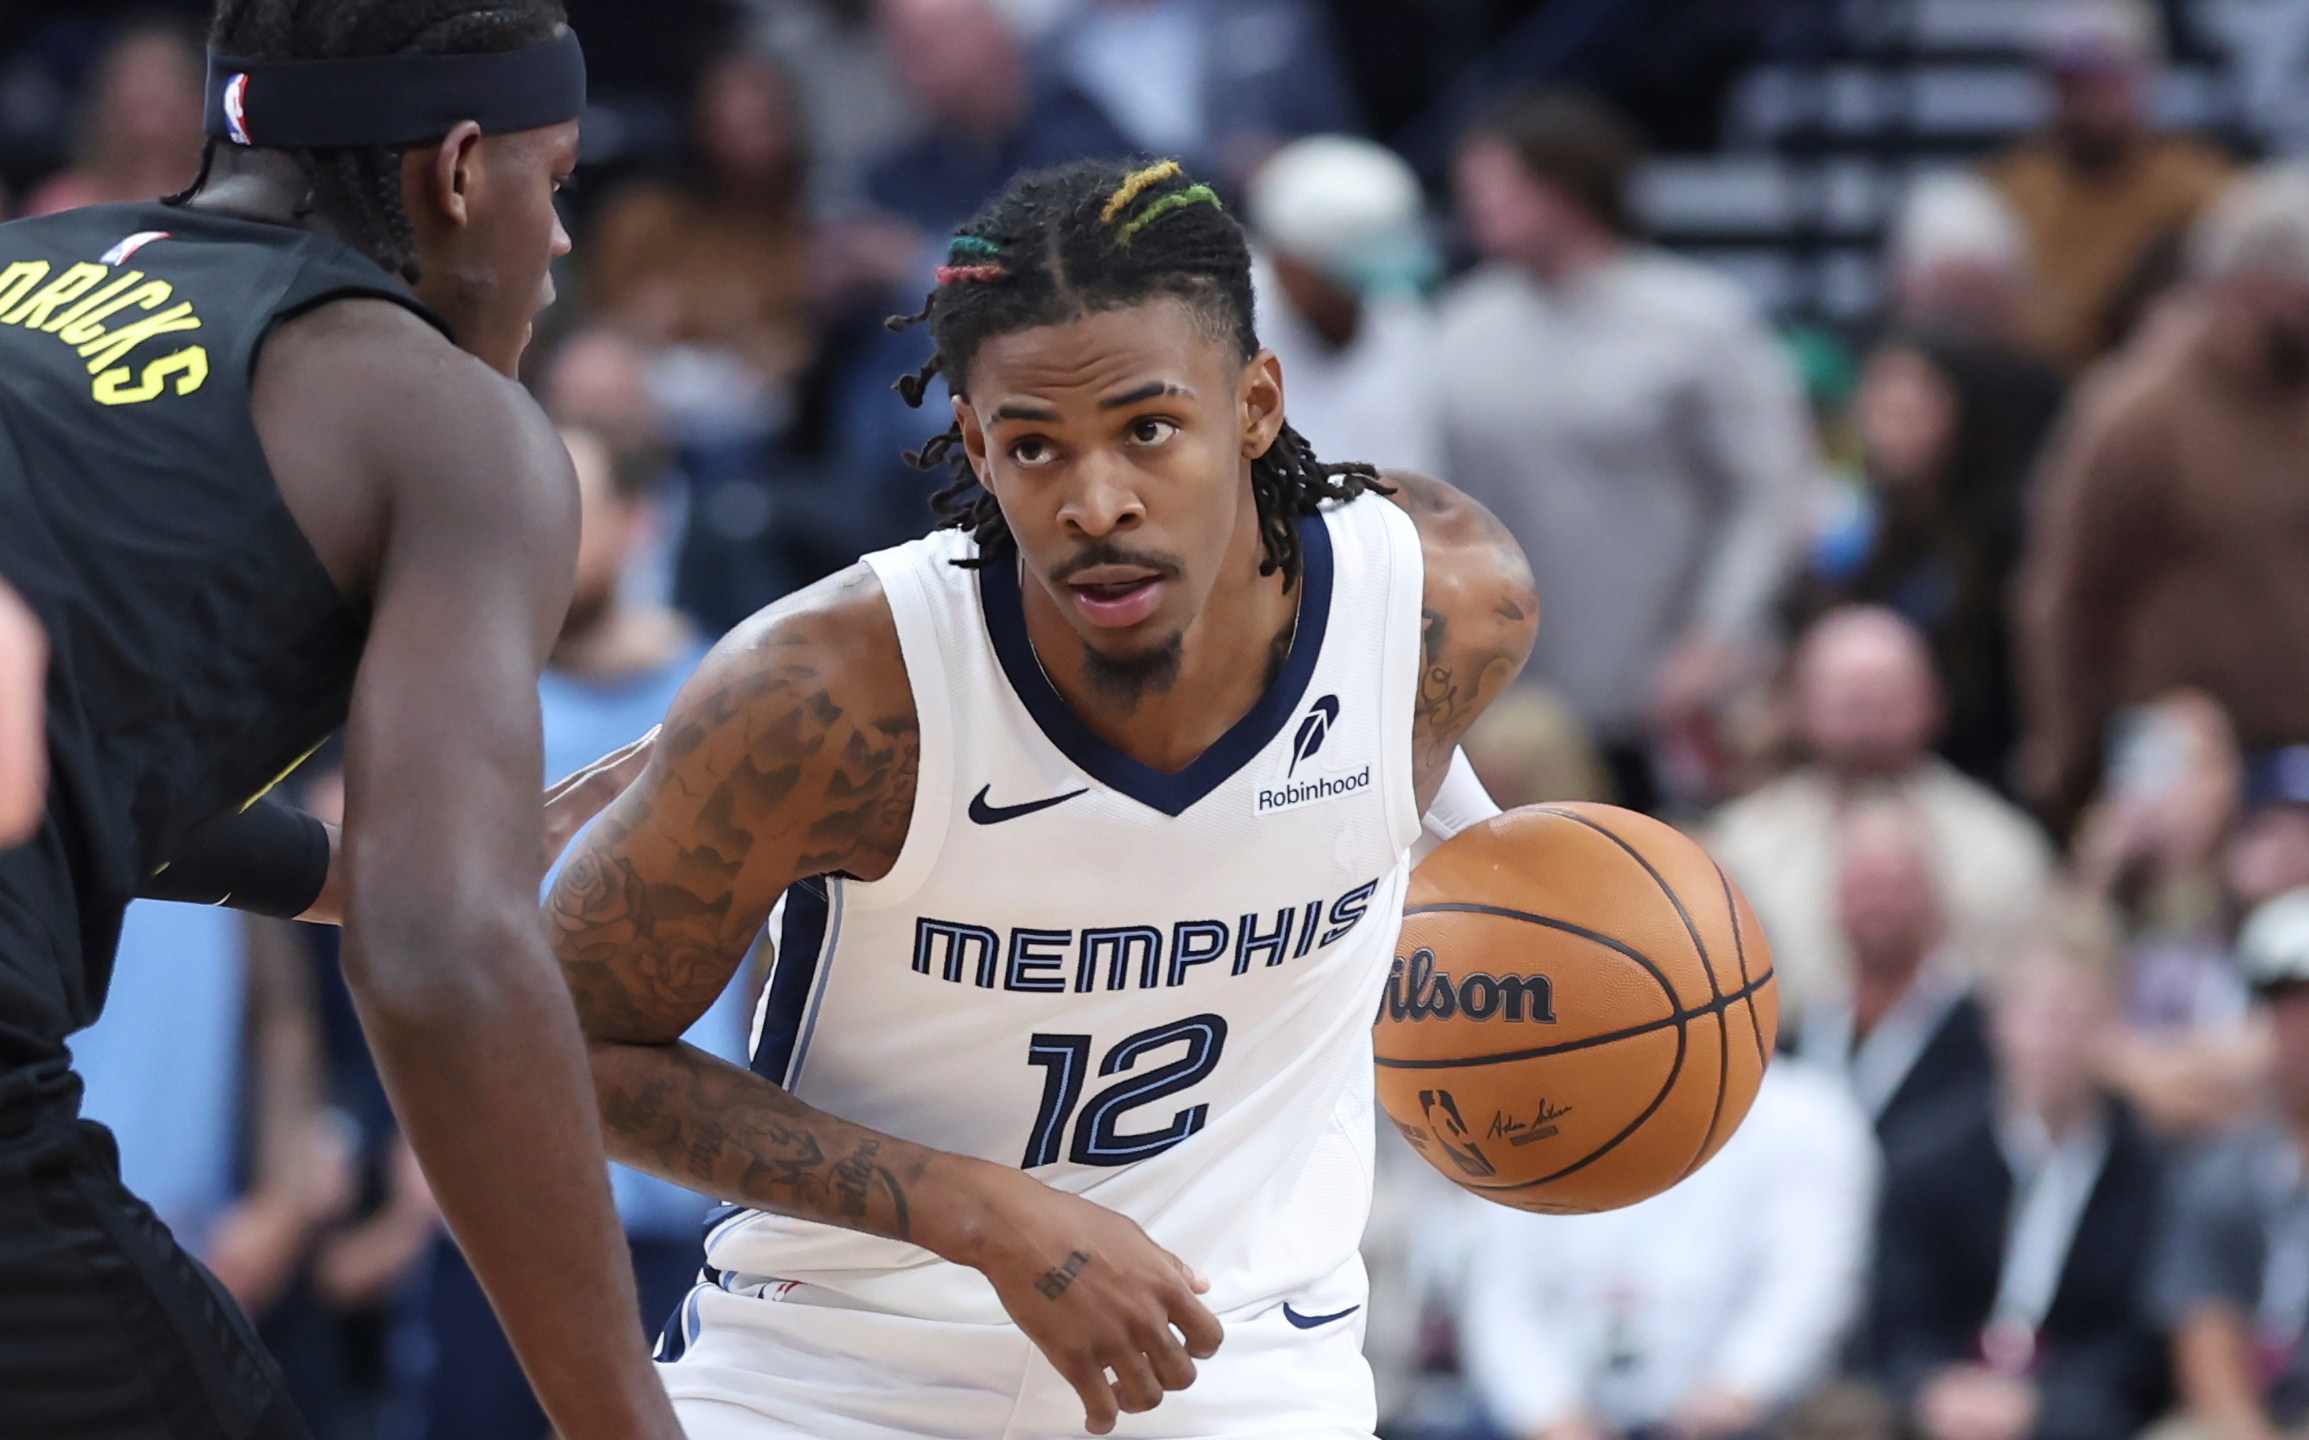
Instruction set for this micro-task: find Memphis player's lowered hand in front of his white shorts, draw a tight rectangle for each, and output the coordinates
[965,1170,1226,1435]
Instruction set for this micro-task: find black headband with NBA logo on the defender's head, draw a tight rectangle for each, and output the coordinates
[208,28,584,150]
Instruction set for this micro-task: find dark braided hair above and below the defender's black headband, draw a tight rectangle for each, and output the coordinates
[169,0,563,282]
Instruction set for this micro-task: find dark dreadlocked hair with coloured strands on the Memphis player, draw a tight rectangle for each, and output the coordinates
[891,159,1388,586]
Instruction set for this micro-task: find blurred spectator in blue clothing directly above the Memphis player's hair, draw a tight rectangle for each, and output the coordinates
[1051,0,1362,185]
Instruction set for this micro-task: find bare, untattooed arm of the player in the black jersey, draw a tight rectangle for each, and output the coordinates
[254,302,677,1438]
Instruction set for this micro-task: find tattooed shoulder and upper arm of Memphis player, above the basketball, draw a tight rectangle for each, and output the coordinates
[1385,471,1540,812]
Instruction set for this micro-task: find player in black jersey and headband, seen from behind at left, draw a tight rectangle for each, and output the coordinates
[0,0,677,1440]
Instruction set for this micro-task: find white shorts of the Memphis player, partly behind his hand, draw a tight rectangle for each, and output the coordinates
[658,1258,1378,1440]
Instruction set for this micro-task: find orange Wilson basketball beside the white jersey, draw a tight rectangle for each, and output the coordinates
[1374,803,1780,1214]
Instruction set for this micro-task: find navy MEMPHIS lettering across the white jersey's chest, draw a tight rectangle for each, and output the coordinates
[914,879,1378,995]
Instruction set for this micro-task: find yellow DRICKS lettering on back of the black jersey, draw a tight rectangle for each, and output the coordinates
[0,246,208,406]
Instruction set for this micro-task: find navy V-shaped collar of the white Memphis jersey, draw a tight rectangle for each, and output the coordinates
[979,515,1330,815]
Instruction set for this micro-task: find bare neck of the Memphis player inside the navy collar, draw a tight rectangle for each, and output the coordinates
[1025,537,1305,775]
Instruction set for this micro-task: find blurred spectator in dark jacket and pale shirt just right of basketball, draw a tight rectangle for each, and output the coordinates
[1766,798,1988,1156]
